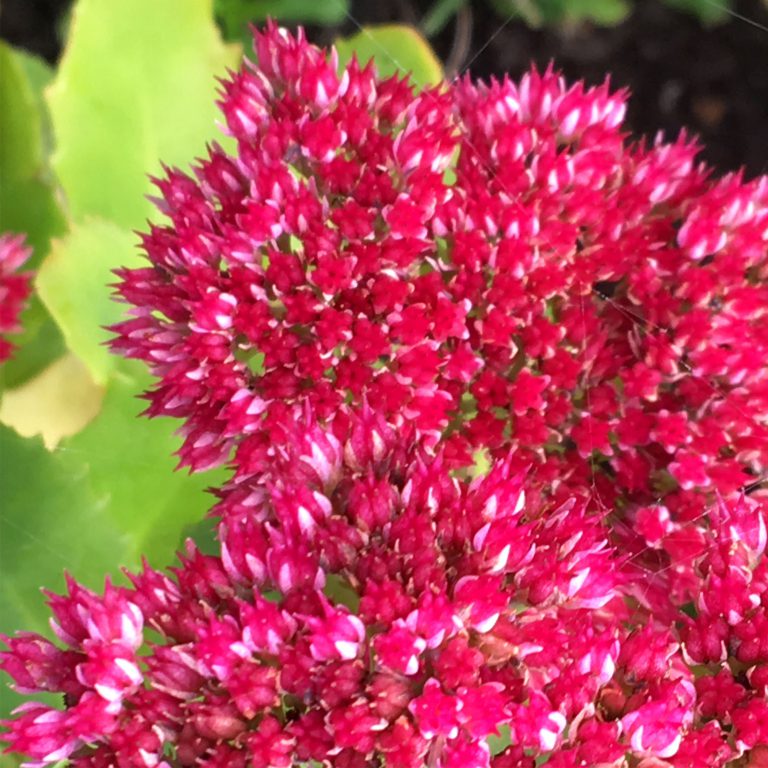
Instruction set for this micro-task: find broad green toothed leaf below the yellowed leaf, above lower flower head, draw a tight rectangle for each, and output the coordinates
[0,364,223,717]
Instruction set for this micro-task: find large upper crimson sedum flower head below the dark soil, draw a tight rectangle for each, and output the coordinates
[106,27,768,615]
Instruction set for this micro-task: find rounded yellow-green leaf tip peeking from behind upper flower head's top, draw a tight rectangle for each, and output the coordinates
[334,24,443,86]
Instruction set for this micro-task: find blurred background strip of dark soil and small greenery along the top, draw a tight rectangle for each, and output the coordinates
[0,0,768,176]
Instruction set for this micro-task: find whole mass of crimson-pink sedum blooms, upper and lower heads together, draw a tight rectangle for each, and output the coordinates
[2,26,768,768]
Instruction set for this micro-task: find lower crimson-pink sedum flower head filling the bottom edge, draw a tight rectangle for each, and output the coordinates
[0,414,768,768]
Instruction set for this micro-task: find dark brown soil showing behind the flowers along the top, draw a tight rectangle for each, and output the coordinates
[0,0,768,177]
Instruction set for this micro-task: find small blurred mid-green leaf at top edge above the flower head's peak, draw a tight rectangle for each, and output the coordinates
[214,0,349,42]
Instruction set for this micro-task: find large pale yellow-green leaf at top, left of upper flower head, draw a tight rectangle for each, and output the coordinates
[48,0,239,228]
